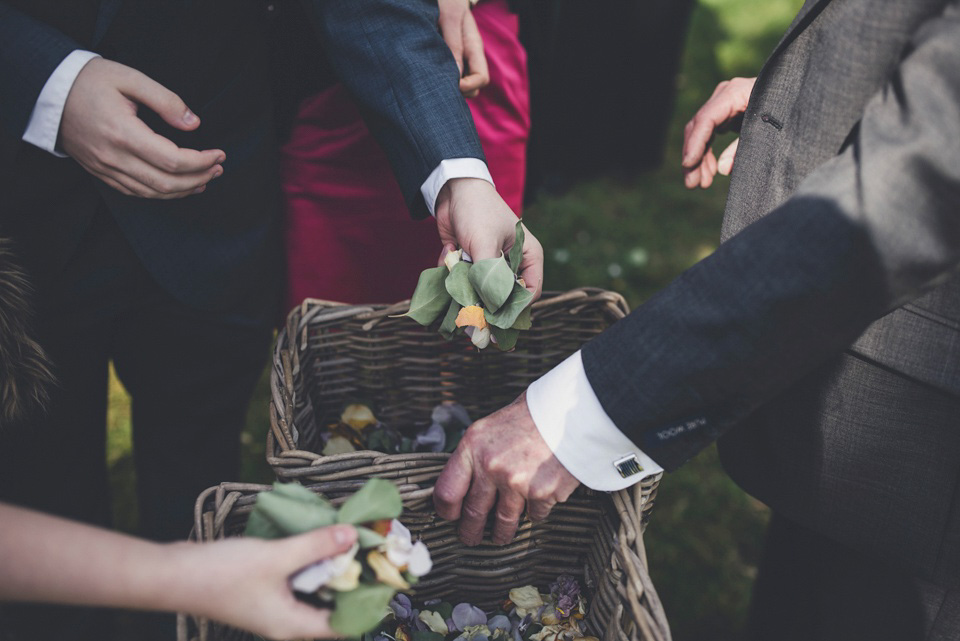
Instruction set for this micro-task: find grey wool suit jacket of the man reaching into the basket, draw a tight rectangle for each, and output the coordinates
[583,0,960,588]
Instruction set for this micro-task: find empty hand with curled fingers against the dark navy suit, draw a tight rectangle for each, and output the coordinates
[60,58,226,199]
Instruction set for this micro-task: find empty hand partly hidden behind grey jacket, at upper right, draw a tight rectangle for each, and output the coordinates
[683,78,757,189]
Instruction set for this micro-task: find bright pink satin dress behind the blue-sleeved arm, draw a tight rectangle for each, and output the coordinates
[281,0,530,312]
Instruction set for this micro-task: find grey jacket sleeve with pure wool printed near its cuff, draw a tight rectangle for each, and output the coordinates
[583,2,960,469]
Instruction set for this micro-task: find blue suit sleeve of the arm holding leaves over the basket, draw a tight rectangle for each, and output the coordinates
[306,0,484,218]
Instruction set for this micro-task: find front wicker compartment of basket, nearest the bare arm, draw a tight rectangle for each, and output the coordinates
[177,479,670,641]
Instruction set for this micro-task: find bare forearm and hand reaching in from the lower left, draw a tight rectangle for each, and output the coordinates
[0,503,357,639]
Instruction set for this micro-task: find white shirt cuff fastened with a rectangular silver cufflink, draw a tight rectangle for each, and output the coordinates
[527,351,663,492]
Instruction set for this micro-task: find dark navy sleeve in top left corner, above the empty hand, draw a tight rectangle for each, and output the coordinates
[0,2,81,140]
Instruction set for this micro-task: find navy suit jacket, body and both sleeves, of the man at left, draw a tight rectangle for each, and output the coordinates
[0,0,483,317]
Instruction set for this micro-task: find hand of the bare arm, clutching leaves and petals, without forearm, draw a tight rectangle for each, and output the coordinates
[170,525,357,639]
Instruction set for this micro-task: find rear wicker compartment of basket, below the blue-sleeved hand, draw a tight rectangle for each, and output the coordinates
[267,288,628,498]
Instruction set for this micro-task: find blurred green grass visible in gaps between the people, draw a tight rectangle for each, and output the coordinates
[108,0,802,641]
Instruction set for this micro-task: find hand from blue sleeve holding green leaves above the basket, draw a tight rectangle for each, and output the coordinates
[436,178,543,300]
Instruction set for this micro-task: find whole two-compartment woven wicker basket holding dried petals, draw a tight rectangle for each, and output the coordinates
[180,288,670,641]
